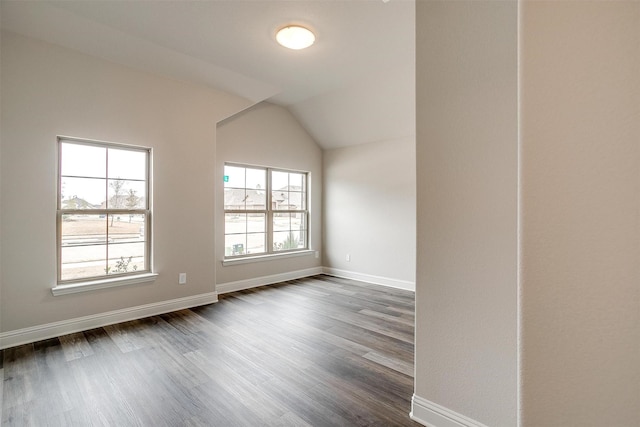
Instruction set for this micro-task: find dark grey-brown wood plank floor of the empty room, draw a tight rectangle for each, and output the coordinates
[0,275,418,426]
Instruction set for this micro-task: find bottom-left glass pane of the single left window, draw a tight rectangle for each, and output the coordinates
[60,245,107,280]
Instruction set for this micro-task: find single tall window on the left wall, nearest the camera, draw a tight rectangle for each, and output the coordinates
[57,138,151,284]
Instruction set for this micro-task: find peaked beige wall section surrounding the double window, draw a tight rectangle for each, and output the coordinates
[215,102,322,288]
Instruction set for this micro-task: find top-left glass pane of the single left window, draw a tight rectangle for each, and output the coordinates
[60,142,107,178]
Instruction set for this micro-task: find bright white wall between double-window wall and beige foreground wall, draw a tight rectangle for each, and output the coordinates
[323,136,416,290]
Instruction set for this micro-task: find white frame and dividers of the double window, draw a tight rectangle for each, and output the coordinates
[223,162,312,265]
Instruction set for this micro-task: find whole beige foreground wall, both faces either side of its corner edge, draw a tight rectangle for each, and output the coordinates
[414,1,640,427]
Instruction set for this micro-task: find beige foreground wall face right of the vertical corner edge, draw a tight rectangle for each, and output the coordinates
[520,1,640,427]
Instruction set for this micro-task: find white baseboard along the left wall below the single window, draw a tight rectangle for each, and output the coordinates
[0,292,218,349]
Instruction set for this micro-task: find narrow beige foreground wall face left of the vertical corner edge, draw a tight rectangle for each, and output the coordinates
[413,1,518,427]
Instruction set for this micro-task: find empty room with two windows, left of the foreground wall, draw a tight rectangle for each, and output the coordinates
[1,1,415,426]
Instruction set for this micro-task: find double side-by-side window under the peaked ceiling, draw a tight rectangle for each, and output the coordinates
[224,164,309,258]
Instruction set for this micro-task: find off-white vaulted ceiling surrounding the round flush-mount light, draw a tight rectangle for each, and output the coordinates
[1,0,415,148]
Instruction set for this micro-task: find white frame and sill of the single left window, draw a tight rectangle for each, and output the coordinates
[51,135,157,290]
